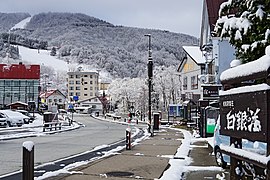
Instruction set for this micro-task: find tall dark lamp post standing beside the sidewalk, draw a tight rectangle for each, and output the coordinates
[144,34,154,136]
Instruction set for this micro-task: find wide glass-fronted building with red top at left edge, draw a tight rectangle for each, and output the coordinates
[0,63,40,108]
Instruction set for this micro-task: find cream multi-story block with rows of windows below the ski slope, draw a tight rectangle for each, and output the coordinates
[67,71,99,101]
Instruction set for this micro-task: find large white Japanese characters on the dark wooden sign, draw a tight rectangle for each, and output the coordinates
[226,108,261,132]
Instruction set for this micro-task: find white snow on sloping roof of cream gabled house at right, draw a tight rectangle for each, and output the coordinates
[183,46,205,64]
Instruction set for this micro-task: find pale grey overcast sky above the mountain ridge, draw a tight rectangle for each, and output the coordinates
[0,0,202,37]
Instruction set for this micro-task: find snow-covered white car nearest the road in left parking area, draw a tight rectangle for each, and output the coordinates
[0,110,30,127]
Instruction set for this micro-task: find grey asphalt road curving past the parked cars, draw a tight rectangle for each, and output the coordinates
[0,115,130,176]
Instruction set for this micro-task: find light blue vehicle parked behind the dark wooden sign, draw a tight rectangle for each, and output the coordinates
[213,116,266,168]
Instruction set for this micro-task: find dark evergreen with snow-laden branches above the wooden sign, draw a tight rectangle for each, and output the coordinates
[215,0,270,63]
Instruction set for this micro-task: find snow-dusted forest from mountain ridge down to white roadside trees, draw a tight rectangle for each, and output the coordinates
[0,13,198,113]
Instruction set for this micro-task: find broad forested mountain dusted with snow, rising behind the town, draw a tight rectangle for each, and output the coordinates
[0,13,198,77]
